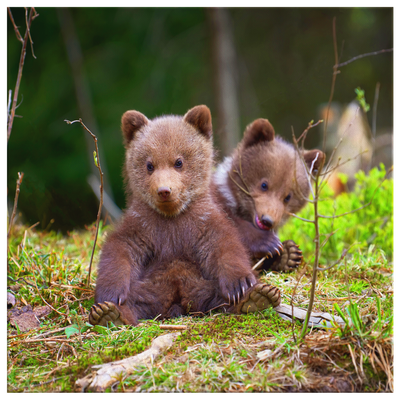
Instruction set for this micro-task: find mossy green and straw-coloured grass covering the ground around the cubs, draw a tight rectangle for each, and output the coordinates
[5,168,395,394]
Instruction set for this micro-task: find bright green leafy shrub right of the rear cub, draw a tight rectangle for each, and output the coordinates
[279,164,396,264]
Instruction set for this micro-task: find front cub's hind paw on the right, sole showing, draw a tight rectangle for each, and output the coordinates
[238,283,281,314]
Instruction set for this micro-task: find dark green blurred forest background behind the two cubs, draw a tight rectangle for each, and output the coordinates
[4,5,396,231]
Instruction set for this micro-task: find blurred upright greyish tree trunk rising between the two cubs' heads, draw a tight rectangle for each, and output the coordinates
[207,8,240,157]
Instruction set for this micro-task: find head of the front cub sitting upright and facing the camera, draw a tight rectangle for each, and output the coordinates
[121,105,213,217]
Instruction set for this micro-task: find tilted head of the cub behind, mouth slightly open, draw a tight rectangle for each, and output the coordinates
[228,118,325,230]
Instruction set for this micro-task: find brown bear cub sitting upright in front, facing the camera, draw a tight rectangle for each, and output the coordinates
[89,105,280,325]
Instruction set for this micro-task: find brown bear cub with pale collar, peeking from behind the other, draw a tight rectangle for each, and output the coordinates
[212,118,325,271]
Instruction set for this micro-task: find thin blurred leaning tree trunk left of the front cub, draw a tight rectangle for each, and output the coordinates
[56,5,120,219]
